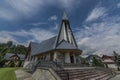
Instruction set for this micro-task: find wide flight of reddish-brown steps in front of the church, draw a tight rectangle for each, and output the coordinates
[56,69,114,80]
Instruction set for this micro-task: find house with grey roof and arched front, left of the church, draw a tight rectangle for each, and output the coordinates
[4,53,25,67]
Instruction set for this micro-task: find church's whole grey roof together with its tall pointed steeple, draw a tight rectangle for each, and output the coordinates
[27,13,79,55]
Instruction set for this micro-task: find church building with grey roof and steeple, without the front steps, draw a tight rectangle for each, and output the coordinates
[26,13,82,64]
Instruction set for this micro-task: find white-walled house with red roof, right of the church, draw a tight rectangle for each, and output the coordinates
[102,55,117,68]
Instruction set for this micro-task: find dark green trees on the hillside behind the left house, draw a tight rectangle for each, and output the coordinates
[0,41,27,67]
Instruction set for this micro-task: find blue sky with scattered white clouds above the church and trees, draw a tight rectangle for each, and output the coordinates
[0,0,120,55]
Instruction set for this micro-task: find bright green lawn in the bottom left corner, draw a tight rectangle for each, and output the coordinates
[0,68,18,80]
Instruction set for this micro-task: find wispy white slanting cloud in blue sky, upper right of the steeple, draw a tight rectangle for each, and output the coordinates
[86,7,107,22]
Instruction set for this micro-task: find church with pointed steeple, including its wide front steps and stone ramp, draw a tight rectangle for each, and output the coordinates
[22,13,115,80]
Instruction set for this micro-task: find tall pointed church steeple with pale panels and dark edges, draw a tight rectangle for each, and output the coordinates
[55,13,78,47]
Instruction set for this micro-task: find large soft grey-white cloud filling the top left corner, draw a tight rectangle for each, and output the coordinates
[0,0,42,21]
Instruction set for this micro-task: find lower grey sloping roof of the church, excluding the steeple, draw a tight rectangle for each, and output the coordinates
[30,36,79,55]
